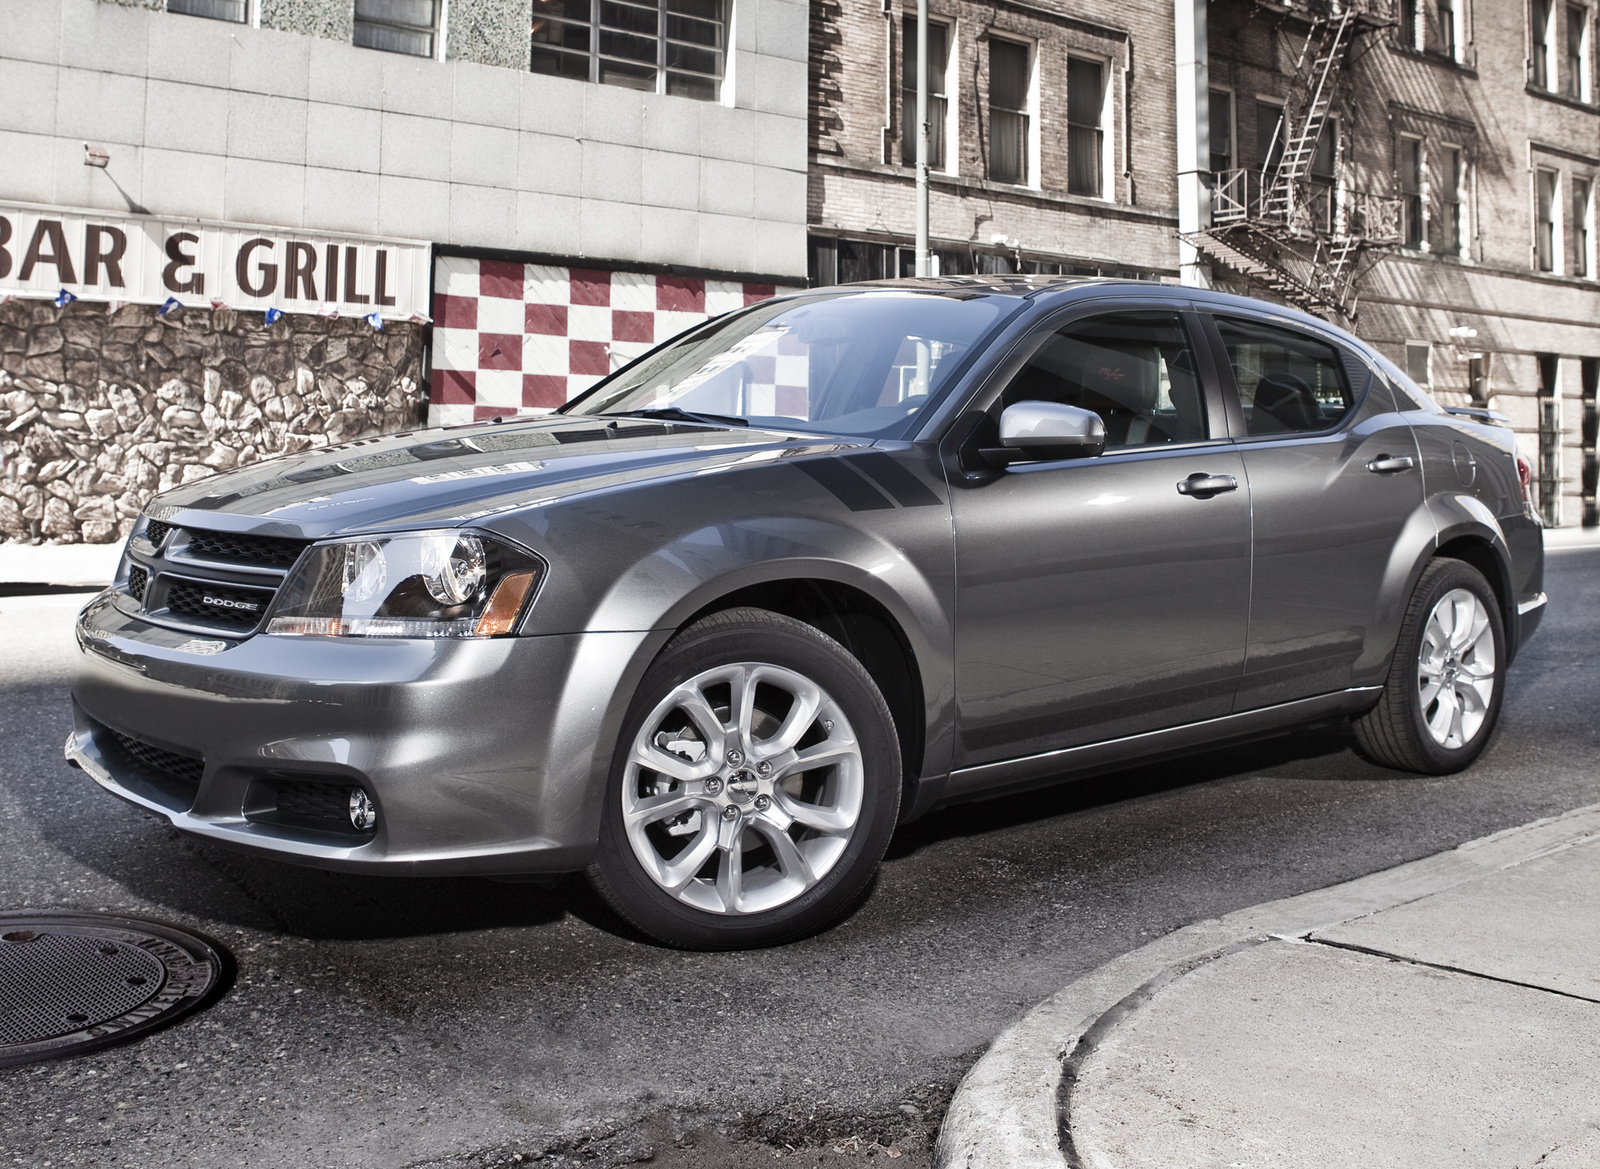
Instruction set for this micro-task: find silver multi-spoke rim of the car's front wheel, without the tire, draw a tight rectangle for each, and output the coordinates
[622,662,866,915]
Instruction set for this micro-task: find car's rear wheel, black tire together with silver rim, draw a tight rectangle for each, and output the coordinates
[1355,558,1506,776]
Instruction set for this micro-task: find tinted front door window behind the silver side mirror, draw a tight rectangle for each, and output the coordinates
[1000,312,1206,449]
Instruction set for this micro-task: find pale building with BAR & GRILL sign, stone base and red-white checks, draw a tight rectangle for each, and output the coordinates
[0,0,806,541]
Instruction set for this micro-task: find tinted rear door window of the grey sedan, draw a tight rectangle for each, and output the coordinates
[1216,317,1352,435]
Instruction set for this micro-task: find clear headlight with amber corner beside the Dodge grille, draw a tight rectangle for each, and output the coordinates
[267,531,544,638]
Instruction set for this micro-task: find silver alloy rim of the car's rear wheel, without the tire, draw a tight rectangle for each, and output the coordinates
[1416,588,1494,750]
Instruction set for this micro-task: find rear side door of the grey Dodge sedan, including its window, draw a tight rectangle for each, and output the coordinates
[1210,313,1422,710]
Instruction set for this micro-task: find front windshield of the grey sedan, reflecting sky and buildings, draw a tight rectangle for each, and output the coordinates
[568,289,1014,435]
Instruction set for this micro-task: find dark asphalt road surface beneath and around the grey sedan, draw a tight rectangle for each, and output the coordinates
[9,550,1600,1167]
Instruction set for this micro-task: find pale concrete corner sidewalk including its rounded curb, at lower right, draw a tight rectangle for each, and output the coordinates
[936,806,1600,1169]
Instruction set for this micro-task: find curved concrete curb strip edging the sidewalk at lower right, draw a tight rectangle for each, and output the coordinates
[933,804,1600,1169]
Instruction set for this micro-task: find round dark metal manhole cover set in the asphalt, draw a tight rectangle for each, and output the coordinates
[0,912,234,1067]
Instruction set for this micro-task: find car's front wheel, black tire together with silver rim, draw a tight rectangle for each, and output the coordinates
[589,609,901,950]
